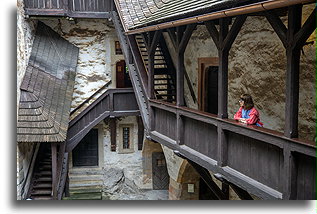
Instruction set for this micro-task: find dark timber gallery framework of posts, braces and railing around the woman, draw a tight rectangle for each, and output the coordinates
[115,1,316,199]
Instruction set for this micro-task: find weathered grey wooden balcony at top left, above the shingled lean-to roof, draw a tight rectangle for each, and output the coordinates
[24,0,114,18]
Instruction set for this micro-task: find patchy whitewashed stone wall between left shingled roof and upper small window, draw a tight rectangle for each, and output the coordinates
[42,19,123,113]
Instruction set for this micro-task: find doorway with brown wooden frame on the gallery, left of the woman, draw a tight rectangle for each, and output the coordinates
[198,57,218,114]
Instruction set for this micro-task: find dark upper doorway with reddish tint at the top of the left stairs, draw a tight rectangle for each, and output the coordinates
[116,60,132,88]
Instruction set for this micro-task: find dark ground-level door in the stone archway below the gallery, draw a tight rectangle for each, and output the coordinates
[152,152,170,189]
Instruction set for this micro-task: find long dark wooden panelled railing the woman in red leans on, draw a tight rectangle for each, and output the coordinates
[149,100,316,199]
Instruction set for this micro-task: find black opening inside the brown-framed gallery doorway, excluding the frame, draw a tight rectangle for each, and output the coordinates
[205,66,218,114]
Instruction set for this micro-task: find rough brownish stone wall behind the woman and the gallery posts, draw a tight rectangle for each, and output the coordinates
[164,5,316,140]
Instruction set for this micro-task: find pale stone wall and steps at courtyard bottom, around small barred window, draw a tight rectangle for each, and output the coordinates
[69,116,148,200]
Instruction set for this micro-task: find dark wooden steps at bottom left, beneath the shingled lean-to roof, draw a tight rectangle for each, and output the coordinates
[28,143,52,200]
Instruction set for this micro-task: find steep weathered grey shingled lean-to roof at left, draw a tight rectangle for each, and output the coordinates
[17,22,79,142]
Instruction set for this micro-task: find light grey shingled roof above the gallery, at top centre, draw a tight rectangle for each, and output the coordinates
[114,0,254,31]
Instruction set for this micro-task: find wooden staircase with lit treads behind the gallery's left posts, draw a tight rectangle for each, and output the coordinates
[135,34,176,103]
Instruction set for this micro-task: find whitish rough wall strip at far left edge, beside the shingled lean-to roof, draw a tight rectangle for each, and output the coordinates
[17,0,36,200]
